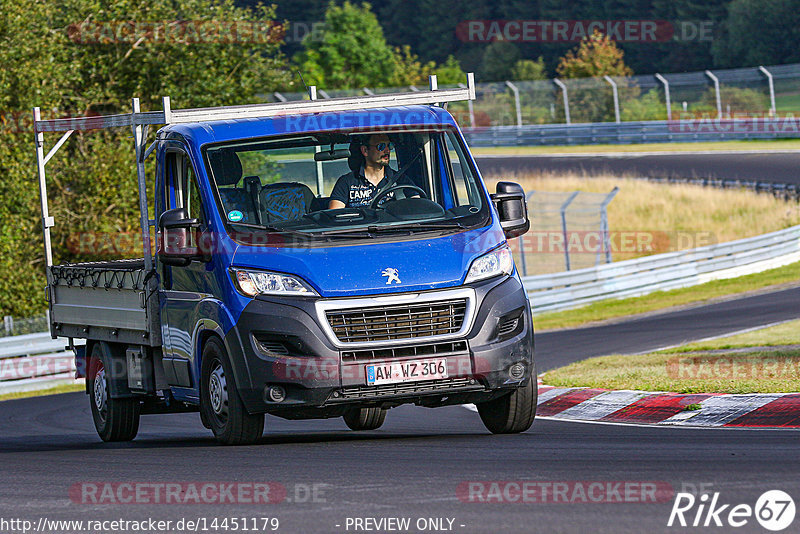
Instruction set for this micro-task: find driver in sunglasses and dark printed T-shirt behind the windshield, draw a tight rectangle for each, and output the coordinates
[328,134,414,209]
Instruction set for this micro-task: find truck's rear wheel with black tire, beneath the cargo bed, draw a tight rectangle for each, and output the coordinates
[88,343,141,441]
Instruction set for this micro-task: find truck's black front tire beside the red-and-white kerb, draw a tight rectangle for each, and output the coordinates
[476,374,539,434]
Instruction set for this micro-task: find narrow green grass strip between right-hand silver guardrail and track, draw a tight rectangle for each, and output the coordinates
[534,262,800,331]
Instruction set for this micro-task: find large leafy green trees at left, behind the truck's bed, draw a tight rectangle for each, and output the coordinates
[0,0,286,317]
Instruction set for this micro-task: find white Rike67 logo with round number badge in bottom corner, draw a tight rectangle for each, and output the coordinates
[667,490,795,532]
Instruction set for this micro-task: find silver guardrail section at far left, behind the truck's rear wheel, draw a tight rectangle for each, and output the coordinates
[0,332,80,394]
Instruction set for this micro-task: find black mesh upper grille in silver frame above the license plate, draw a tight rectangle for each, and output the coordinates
[325,299,467,343]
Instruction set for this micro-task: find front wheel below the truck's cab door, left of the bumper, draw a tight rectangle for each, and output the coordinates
[200,338,264,445]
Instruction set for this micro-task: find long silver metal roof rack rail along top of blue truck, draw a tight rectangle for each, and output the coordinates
[34,73,475,133]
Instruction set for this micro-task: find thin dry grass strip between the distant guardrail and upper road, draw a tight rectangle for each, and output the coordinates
[472,139,800,156]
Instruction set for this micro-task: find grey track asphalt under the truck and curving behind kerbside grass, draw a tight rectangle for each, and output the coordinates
[0,289,800,534]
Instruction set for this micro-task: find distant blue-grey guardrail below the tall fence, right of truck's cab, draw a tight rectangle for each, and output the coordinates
[463,118,800,147]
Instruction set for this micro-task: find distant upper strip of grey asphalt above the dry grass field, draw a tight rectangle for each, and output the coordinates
[476,152,800,184]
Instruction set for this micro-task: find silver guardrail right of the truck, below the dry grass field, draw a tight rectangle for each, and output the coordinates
[522,226,800,314]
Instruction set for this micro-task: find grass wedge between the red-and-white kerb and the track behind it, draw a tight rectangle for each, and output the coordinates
[544,320,800,396]
